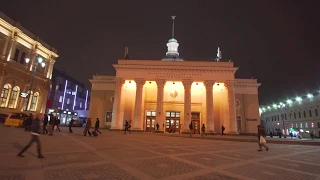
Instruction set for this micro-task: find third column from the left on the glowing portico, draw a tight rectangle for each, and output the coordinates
[156,79,166,131]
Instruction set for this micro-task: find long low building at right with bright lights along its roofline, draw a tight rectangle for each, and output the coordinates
[260,92,320,137]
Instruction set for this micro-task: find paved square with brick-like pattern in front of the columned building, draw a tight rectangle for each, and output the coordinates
[0,126,320,180]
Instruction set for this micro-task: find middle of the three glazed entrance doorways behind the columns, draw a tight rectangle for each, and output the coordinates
[166,111,180,133]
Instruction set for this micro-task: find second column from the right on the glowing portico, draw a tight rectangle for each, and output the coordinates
[204,80,215,133]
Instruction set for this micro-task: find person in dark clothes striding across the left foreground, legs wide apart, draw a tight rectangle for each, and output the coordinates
[17,115,44,158]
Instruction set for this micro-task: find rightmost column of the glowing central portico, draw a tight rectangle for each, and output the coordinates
[226,81,238,134]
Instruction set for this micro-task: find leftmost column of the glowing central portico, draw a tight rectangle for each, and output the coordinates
[110,78,124,130]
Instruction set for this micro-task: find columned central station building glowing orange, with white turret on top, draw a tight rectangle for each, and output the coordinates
[89,16,260,134]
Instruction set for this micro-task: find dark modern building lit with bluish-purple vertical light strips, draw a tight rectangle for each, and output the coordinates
[47,68,90,124]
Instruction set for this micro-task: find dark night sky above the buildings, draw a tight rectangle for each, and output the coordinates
[0,0,320,104]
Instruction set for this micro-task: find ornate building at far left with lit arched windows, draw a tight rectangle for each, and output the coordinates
[0,12,58,114]
